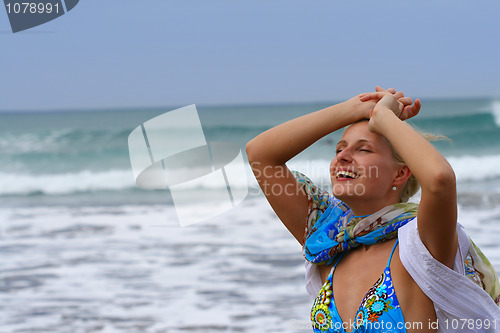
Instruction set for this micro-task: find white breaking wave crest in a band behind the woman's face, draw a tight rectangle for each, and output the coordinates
[0,155,500,196]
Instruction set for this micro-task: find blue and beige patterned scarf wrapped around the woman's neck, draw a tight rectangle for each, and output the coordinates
[304,198,418,265]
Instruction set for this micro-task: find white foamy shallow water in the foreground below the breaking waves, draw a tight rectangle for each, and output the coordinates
[0,192,500,333]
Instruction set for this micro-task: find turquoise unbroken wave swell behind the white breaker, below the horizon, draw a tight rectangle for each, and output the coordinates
[0,105,500,160]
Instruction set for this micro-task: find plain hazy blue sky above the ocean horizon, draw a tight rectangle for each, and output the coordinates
[0,0,500,111]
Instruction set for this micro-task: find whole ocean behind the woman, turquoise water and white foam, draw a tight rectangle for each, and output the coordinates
[0,98,500,333]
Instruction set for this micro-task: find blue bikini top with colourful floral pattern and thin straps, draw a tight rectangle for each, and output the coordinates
[311,241,406,333]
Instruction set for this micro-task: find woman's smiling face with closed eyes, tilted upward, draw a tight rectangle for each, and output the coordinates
[330,121,399,205]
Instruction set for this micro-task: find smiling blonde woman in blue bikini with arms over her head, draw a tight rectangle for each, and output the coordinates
[246,87,500,332]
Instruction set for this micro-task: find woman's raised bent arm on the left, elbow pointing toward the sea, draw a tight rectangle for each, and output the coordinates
[246,95,375,244]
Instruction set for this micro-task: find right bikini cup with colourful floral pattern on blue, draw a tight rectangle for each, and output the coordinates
[354,268,399,330]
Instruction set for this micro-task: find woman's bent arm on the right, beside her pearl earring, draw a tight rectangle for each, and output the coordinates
[362,92,458,268]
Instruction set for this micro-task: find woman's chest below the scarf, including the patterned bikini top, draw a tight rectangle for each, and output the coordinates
[311,242,436,332]
